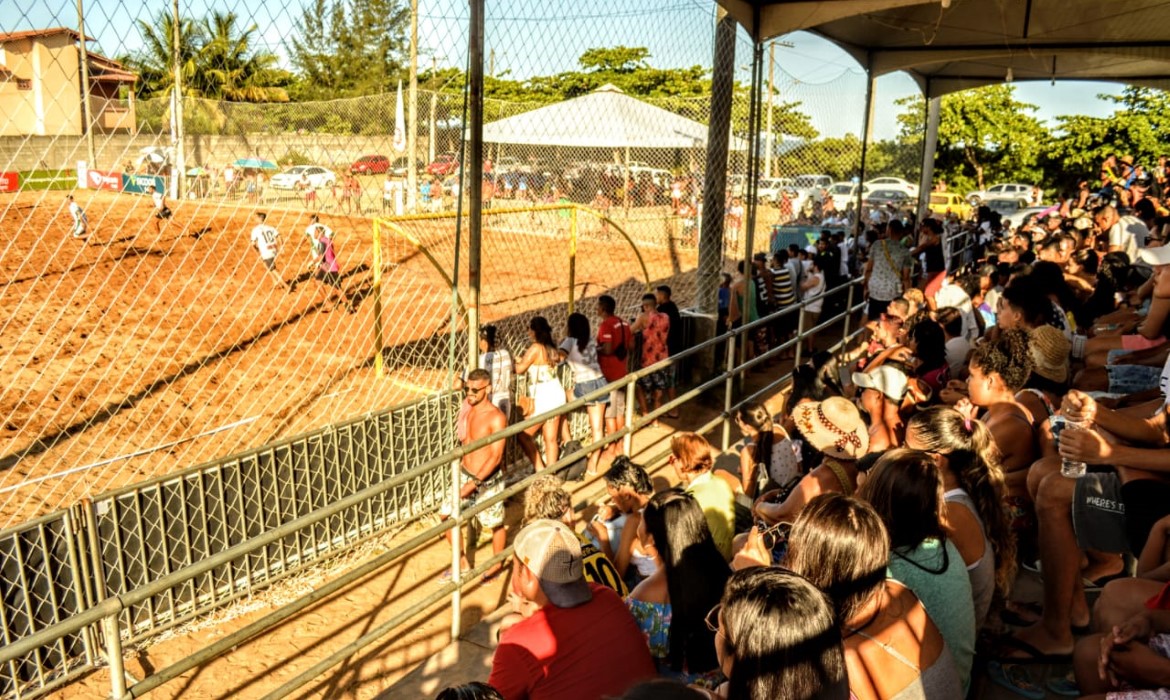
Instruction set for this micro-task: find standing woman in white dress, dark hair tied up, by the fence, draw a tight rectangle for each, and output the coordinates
[516,316,565,472]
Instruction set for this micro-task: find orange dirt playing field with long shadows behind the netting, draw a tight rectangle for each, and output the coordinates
[0,191,695,528]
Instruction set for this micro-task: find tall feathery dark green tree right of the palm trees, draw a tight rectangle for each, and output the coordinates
[289,0,411,99]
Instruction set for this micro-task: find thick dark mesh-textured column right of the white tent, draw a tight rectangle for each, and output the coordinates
[695,7,736,376]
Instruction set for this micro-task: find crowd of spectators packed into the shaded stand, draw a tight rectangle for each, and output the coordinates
[443,159,1170,700]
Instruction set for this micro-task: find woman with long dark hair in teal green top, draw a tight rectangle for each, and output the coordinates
[858,448,976,691]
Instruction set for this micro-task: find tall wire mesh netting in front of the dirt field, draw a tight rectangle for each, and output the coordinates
[0,0,921,523]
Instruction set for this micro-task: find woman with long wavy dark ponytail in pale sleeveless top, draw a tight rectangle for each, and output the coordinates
[906,406,1016,625]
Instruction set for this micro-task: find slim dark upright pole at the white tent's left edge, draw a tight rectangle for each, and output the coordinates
[465,0,483,369]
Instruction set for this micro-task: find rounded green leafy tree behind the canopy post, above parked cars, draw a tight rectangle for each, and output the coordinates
[897,85,1048,190]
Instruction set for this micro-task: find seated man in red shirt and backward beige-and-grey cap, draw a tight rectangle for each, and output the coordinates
[488,520,655,700]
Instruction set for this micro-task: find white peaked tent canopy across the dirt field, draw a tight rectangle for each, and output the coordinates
[472,84,745,151]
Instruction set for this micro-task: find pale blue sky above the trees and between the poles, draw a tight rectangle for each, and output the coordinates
[9,0,1121,138]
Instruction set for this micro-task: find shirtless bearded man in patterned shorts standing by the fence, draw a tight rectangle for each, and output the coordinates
[439,370,508,582]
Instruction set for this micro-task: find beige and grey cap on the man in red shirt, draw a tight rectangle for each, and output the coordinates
[515,520,593,608]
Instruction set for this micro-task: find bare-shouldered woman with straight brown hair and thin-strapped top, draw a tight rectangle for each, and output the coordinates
[784,494,963,700]
